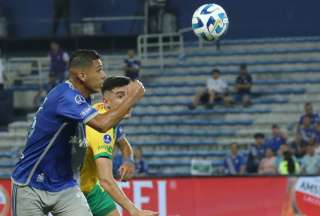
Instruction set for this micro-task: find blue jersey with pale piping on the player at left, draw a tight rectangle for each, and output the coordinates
[12,81,98,192]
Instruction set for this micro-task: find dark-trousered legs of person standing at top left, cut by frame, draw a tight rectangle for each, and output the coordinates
[52,0,70,36]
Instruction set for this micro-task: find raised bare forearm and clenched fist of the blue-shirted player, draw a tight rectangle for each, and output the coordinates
[87,81,145,132]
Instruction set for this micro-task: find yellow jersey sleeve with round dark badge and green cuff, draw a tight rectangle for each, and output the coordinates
[86,126,113,160]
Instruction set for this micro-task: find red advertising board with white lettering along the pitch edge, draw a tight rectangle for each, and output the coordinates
[0,177,320,216]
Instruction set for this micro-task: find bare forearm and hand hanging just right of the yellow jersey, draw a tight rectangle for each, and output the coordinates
[116,137,135,181]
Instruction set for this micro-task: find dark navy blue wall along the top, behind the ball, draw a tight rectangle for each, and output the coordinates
[0,0,320,38]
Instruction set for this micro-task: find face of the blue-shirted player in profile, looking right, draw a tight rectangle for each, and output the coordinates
[84,59,106,93]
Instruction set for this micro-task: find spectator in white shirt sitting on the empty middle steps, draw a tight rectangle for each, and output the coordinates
[189,69,232,109]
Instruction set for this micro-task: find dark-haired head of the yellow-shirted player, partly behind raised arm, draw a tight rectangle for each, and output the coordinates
[101,76,130,109]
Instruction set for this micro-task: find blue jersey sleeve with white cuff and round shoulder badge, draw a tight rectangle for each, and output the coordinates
[57,91,98,123]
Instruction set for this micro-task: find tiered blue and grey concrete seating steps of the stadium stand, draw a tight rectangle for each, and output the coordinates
[0,37,320,176]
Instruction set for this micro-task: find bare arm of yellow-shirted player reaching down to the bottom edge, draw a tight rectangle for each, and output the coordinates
[95,158,158,216]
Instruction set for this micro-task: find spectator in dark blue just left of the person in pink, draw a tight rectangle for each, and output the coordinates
[247,133,266,173]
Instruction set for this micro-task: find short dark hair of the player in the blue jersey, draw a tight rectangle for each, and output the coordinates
[69,49,101,68]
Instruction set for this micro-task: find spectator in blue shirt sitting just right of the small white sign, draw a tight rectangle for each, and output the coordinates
[224,143,246,175]
